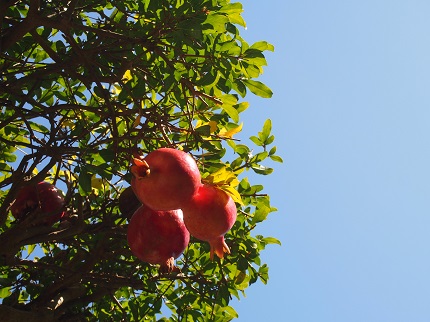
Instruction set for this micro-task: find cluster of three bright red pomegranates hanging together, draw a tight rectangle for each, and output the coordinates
[127,148,237,271]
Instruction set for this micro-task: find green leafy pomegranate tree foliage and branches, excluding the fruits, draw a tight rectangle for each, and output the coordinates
[0,0,282,321]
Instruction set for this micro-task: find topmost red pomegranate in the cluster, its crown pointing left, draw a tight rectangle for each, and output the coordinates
[131,148,201,210]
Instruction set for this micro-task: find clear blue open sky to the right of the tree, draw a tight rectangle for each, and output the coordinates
[233,0,430,322]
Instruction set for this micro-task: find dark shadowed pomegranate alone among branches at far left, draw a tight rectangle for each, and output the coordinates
[10,181,66,225]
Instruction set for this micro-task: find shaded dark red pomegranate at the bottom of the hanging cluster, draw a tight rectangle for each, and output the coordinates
[127,205,190,272]
